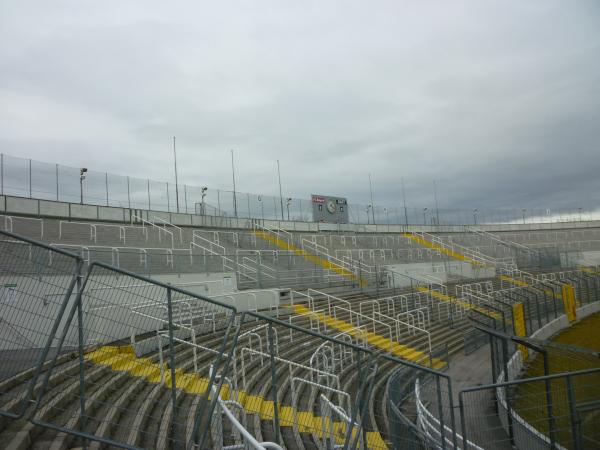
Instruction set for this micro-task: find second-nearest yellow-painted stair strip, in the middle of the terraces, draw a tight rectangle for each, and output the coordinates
[294,304,446,369]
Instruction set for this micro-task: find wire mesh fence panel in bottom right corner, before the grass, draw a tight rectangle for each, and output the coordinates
[459,369,600,449]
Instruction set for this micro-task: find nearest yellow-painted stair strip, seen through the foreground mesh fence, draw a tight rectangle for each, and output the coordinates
[85,345,389,450]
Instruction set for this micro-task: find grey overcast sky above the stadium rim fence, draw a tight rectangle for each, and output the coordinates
[0,0,600,208]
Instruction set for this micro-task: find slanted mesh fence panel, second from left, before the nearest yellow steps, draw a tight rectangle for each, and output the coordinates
[30,263,236,448]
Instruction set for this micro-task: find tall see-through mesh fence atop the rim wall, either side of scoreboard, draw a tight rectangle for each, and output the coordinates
[0,154,593,225]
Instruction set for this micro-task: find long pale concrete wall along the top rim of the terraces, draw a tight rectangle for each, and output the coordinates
[0,196,600,233]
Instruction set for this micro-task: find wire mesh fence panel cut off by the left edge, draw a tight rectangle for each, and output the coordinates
[0,231,82,418]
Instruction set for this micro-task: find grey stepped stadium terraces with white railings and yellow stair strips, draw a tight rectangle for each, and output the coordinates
[0,218,600,449]
